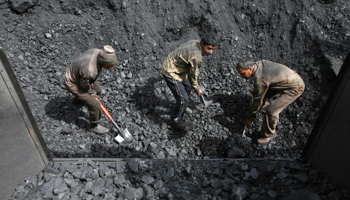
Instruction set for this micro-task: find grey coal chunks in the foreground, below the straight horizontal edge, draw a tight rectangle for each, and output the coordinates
[10,158,350,200]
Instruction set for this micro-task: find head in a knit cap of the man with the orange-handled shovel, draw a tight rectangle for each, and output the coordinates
[97,45,117,69]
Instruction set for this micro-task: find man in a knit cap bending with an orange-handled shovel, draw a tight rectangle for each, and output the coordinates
[64,45,117,134]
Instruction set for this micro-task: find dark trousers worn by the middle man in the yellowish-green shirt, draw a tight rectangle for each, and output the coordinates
[163,74,192,122]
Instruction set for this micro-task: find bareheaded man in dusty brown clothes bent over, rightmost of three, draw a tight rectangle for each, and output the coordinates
[236,59,305,144]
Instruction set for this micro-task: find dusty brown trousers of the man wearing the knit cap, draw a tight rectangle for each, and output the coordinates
[66,81,102,127]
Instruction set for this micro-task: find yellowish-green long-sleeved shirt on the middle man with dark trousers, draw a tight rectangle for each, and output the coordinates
[161,40,204,92]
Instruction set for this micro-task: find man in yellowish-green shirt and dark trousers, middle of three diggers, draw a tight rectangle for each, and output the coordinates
[161,34,217,129]
